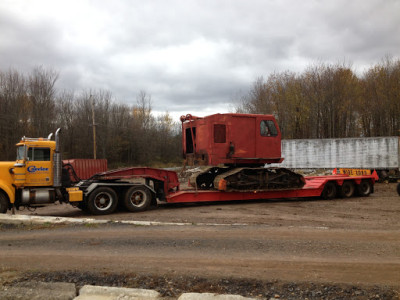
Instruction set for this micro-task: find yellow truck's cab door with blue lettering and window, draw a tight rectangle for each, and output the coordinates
[25,147,53,186]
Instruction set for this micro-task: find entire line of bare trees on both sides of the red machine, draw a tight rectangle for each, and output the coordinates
[0,57,400,167]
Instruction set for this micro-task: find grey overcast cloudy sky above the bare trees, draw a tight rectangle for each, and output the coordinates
[0,0,400,117]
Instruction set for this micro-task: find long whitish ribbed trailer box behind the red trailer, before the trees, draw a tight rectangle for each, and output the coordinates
[274,136,400,170]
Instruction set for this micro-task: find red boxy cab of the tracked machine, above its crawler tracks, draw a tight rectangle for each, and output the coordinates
[181,113,283,166]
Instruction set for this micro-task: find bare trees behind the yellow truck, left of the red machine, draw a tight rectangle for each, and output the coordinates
[0,67,181,167]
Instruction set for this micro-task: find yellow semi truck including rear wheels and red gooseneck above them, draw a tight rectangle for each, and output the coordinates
[0,129,172,214]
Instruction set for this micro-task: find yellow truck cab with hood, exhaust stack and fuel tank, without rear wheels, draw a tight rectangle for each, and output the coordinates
[0,130,82,213]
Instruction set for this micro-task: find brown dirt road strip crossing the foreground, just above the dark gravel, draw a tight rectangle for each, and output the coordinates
[0,225,400,285]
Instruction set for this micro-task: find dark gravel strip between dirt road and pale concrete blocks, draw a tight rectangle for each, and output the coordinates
[6,272,399,299]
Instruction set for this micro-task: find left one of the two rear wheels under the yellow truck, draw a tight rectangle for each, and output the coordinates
[87,187,118,215]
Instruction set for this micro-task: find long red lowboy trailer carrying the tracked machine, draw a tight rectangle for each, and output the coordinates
[95,168,377,207]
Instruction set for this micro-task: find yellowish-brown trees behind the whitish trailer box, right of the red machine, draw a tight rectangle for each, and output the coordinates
[235,57,400,139]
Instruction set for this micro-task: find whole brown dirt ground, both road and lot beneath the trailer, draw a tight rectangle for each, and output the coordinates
[0,184,400,299]
